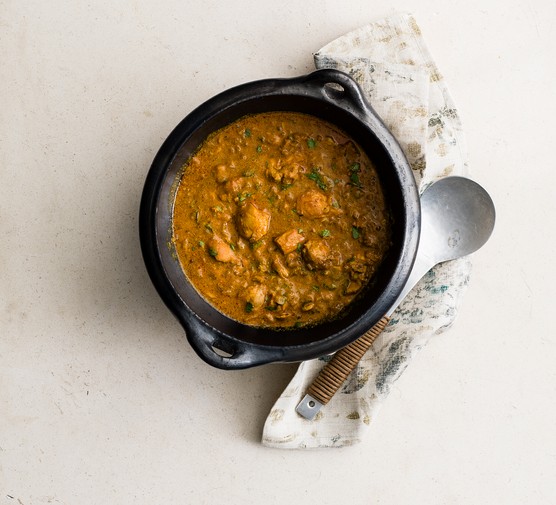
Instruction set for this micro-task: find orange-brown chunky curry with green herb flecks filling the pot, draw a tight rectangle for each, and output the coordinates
[172,112,390,328]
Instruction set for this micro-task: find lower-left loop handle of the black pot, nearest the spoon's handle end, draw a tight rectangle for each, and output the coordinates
[179,311,283,370]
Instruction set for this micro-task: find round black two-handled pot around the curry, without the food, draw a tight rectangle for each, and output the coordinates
[139,70,420,369]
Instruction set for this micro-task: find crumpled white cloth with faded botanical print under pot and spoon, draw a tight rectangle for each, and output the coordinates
[262,14,471,449]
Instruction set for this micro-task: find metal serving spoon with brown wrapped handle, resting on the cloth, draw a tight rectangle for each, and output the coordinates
[295,176,496,420]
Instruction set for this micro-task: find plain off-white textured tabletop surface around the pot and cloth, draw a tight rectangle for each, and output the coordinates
[0,0,556,505]
